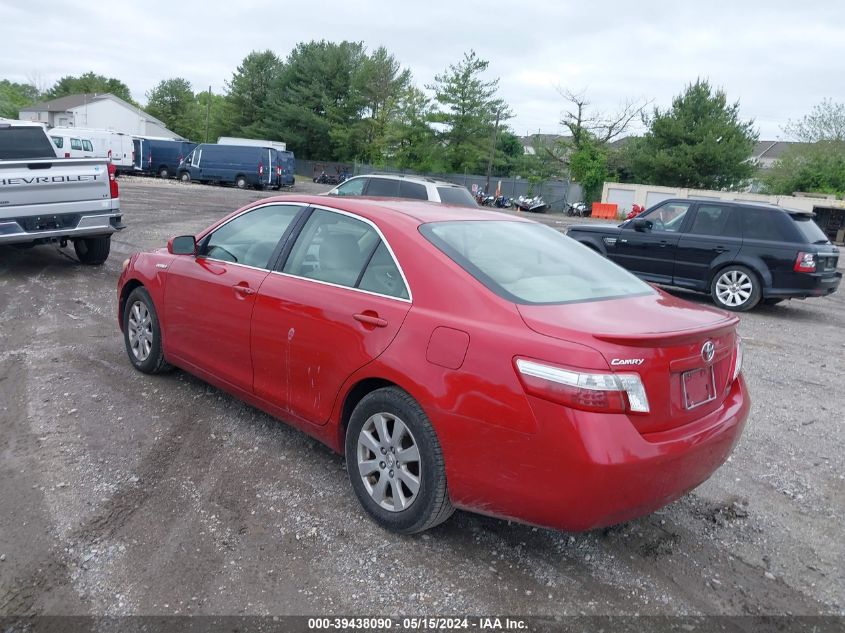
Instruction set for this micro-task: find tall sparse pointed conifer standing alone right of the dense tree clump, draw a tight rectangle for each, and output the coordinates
[427,50,511,172]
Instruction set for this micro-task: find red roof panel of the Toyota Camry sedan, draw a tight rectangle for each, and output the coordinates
[256,194,531,224]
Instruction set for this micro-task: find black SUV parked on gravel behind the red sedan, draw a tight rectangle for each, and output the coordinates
[567,199,842,311]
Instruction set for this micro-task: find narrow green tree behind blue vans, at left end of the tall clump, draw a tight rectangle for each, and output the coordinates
[223,50,284,136]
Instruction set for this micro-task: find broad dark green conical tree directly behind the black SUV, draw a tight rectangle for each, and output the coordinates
[632,79,757,190]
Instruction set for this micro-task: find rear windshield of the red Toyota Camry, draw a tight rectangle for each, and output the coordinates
[420,220,654,304]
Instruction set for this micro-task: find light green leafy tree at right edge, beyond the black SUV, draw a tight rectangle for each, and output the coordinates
[762,100,845,196]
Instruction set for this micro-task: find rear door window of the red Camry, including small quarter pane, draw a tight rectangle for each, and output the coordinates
[282,209,410,299]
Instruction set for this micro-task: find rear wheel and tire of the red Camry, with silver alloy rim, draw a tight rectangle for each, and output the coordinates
[345,387,454,534]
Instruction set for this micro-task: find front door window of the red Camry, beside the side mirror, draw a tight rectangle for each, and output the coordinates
[199,204,304,268]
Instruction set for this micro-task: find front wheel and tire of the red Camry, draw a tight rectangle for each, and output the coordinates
[123,286,172,374]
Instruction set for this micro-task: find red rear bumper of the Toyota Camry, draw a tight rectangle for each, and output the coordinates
[438,378,751,531]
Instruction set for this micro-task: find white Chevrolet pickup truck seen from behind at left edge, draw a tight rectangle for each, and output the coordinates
[0,119,124,264]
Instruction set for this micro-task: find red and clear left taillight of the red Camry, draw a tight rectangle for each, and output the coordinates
[516,358,649,413]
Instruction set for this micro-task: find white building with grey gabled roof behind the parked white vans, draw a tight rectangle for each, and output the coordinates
[20,94,182,139]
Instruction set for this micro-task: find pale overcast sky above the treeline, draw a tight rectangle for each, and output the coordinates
[0,0,845,140]
